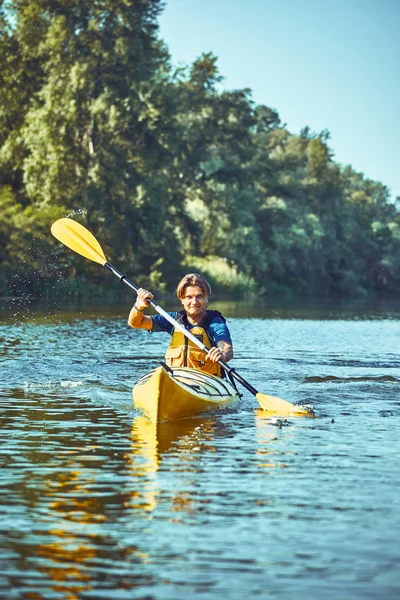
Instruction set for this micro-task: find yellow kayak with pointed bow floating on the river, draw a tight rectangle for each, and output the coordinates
[132,365,239,422]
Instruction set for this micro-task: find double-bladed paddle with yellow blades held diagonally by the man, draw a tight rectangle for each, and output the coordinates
[51,218,310,416]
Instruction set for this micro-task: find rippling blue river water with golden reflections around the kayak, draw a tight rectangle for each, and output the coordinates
[0,300,400,600]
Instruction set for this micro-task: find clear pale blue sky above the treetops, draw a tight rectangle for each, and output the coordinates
[159,0,400,200]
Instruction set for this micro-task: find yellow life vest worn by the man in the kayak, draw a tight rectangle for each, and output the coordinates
[165,326,222,377]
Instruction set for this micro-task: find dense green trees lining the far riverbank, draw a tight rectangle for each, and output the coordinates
[0,0,400,296]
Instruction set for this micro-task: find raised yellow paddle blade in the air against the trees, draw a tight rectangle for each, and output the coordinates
[51,219,107,266]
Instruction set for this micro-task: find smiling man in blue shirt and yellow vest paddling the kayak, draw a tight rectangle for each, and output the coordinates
[128,273,233,377]
